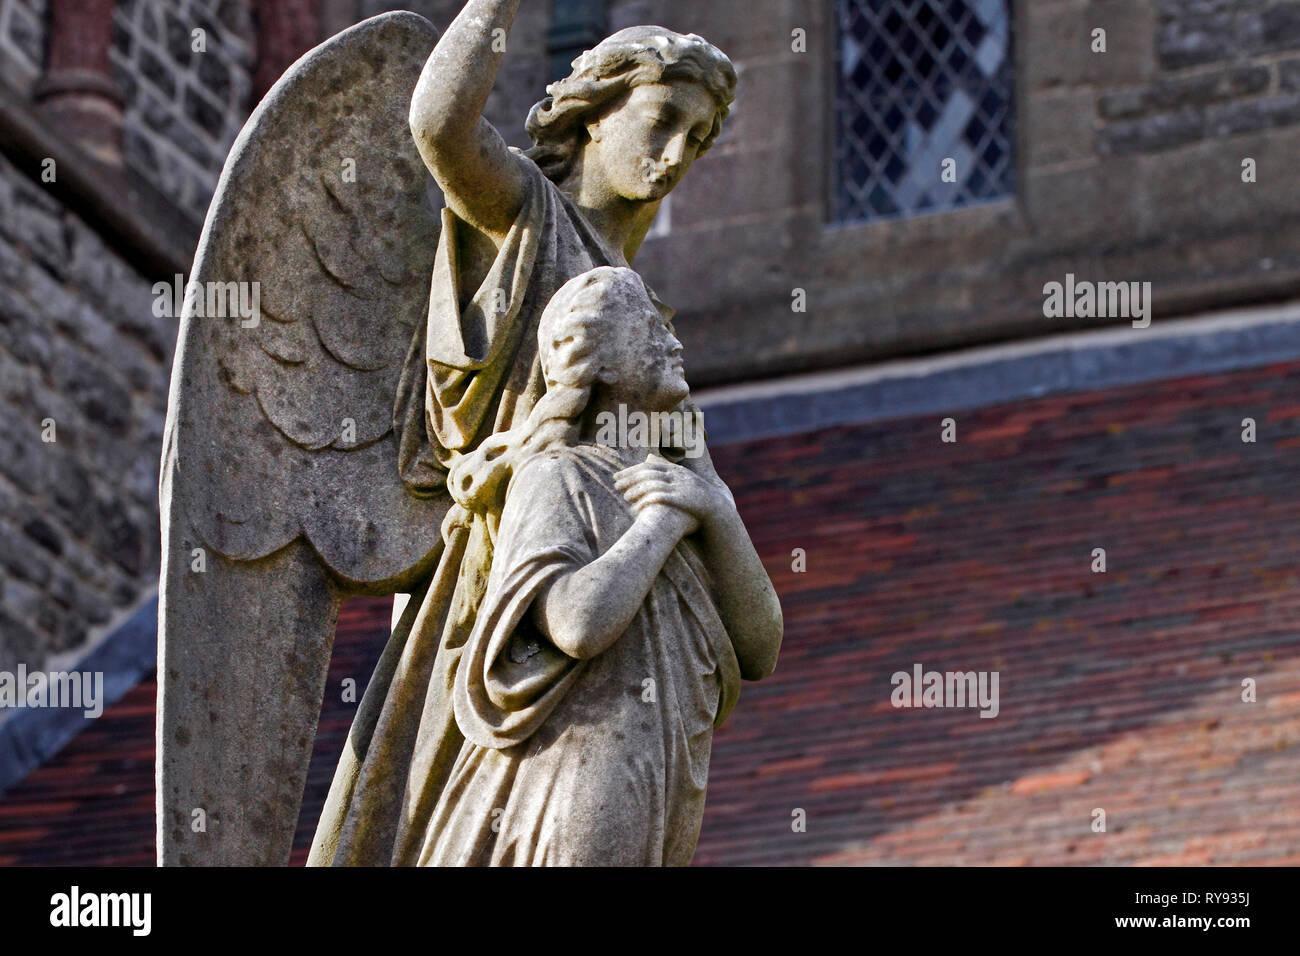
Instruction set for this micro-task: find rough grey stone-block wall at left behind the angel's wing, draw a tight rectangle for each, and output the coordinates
[0,0,550,686]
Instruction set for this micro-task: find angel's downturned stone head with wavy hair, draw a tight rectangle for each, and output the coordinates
[528,26,736,202]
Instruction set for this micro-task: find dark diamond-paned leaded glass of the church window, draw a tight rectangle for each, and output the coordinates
[831,0,1015,222]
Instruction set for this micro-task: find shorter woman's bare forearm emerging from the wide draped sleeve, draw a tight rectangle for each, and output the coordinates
[533,507,697,659]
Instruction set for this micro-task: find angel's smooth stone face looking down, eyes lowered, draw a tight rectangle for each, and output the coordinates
[584,79,718,202]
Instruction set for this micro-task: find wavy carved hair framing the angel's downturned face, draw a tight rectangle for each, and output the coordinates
[525,26,736,182]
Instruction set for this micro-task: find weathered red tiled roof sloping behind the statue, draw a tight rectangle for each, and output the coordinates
[0,363,1300,865]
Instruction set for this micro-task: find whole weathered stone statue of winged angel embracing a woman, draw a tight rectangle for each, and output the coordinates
[157,0,781,865]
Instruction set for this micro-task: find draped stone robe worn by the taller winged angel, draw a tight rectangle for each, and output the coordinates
[308,151,671,866]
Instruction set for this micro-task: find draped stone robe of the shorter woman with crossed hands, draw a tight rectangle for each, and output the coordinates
[420,445,740,866]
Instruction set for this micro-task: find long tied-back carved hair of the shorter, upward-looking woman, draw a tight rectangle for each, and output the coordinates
[447,265,654,512]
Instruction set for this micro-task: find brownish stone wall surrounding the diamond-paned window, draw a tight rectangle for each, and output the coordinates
[614,0,1300,386]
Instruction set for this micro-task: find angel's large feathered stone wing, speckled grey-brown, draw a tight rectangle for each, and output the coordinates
[157,13,449,864]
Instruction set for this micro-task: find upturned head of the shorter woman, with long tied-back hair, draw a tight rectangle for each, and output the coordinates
[447,265,689,511]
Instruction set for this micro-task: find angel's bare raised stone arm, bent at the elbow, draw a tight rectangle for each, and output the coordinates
[411,0,524,241]
